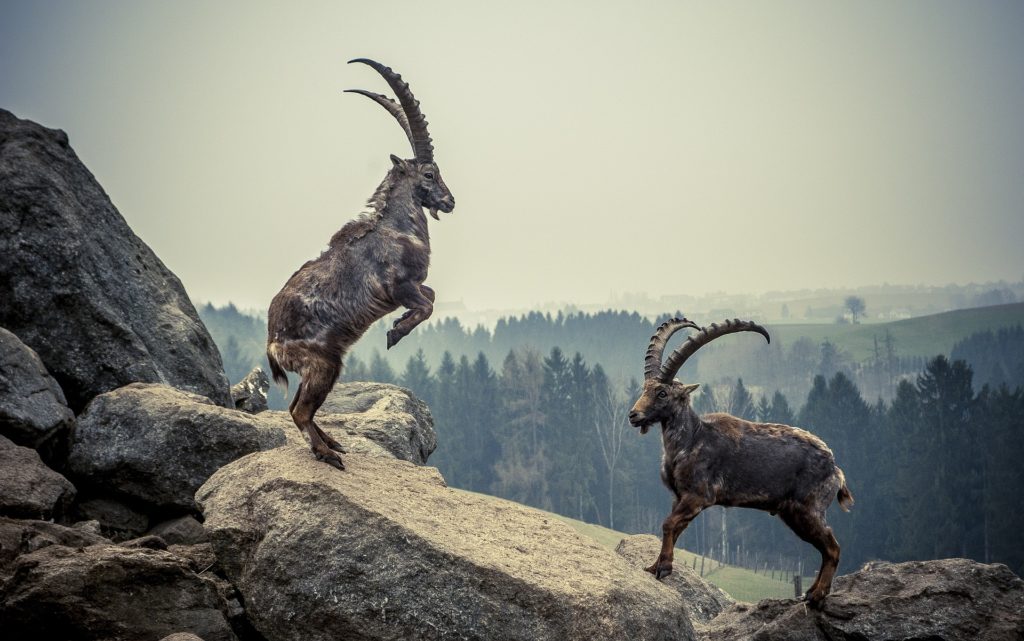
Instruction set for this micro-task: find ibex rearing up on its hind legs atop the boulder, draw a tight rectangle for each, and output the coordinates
[266,58,455,469]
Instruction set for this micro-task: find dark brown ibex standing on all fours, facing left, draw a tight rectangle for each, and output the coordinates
[630,318,853,605]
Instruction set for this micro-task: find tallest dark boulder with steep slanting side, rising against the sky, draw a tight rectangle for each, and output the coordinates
[0,110,231,412]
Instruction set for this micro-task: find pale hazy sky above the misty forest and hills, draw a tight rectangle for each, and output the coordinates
[0,1,1024,308]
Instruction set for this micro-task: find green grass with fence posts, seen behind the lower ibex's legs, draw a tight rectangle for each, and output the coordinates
[459,489,798,602]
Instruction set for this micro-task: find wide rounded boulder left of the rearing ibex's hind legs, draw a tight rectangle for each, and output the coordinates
[68,383,285,513]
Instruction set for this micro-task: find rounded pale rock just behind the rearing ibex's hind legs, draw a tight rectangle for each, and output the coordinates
[317,383,437,465]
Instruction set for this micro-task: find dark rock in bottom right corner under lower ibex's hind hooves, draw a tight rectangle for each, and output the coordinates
[701,559,1024,641]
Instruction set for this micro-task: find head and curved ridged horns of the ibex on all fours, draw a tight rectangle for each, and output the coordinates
[630,318,771,434]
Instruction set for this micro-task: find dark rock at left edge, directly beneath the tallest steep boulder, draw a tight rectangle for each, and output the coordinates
[0,328,75,448]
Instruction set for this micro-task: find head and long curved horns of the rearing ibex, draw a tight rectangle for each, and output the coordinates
[346,58,455,220]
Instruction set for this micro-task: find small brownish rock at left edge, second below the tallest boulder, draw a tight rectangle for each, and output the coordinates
[0,436,76,519]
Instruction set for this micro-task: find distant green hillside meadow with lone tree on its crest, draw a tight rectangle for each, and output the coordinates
[771,303,1024,360]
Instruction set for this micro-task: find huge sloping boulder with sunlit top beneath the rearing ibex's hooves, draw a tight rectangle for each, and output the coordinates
[197,446,692,641]
